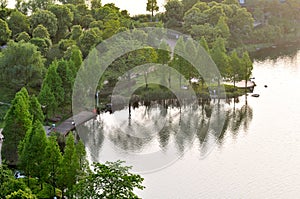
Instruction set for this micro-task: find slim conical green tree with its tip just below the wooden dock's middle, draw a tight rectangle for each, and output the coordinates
[58,133,80,195]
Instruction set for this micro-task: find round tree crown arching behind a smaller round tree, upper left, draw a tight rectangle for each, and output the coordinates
[30,10,58,37]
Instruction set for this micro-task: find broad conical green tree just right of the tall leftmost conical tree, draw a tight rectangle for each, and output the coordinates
[19,120,47,189]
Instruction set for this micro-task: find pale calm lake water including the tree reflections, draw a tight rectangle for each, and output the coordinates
[80,44,300,199]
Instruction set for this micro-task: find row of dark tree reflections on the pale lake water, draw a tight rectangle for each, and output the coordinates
[80,96,253,161]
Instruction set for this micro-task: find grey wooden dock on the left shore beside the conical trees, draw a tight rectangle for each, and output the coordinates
[51,111,97,136]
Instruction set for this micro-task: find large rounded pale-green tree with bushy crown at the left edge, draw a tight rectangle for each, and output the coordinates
[0,41,45,92]
